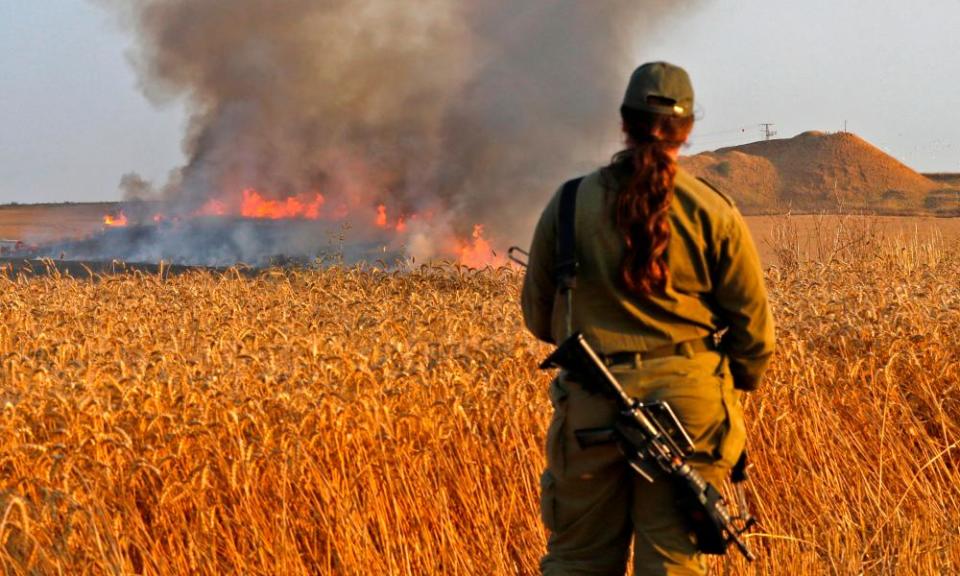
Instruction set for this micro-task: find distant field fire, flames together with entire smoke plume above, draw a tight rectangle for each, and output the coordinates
[18,0,673,266]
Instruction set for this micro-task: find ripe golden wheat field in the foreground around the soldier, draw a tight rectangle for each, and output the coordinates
[0,228,960,575]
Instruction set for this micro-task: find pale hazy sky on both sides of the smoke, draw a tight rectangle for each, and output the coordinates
[0,0,960,203]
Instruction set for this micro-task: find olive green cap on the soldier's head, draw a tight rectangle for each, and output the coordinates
[623,62,693,118]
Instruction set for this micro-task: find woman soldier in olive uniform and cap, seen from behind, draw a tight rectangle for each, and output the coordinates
[522,62,774,575]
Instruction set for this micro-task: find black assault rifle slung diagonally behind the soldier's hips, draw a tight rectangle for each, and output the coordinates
[540,332,756,561]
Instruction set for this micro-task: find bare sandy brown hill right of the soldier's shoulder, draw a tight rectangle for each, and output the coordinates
[681,132,960,212]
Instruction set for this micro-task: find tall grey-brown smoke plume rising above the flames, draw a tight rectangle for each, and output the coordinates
[97,0,677,255]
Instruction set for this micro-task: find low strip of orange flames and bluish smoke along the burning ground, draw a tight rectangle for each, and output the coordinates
[31,195,496,268]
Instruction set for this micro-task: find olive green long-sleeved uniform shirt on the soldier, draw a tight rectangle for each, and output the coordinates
[522,169,774,390]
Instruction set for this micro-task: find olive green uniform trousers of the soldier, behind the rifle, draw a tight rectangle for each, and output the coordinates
[540,352,746,576]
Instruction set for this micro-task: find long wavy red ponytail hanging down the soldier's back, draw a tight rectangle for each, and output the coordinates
[610,108,693,296]
